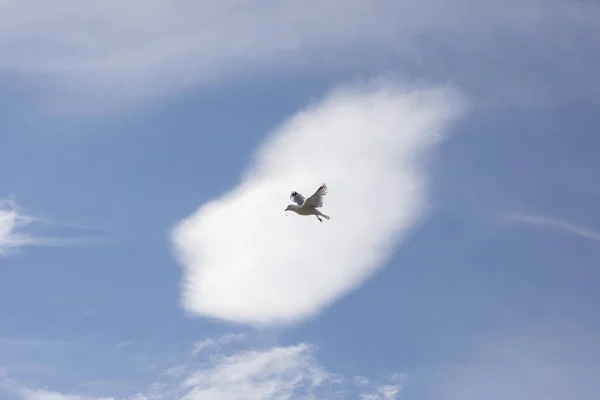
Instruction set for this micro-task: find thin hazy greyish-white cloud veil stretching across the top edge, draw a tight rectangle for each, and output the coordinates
[0,0,597,111]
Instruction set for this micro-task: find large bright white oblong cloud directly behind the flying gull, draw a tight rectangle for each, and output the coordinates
[172,81,462,325]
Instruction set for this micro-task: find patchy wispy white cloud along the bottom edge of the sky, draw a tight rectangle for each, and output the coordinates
[5,337,404,400]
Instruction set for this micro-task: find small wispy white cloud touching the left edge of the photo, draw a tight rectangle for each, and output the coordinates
[0,199,113,257]
